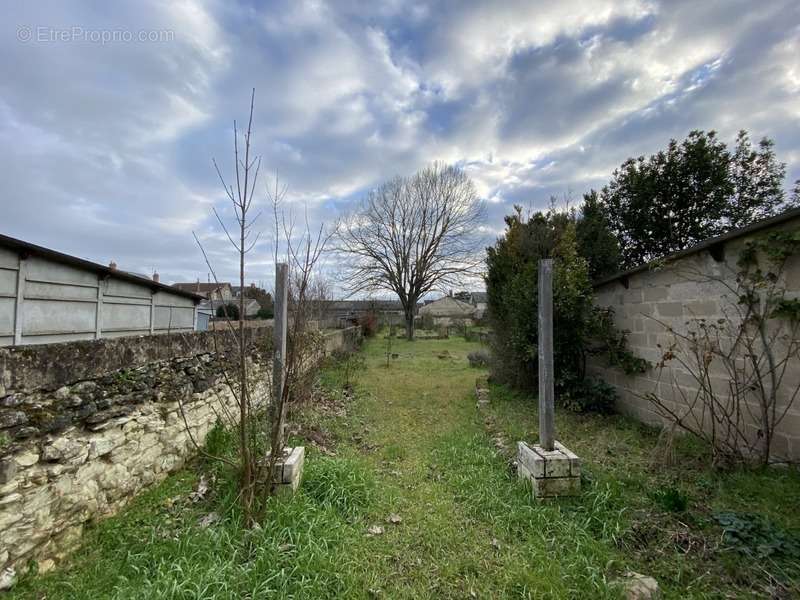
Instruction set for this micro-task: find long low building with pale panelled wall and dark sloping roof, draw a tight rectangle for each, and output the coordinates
[0,235,202,346]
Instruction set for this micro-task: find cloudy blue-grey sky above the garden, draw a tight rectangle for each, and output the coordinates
[0,0,800,290]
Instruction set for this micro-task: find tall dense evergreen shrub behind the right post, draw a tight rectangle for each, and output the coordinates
[486,208,646,412]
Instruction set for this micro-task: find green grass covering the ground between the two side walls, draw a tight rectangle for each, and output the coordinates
[9,337,800,598]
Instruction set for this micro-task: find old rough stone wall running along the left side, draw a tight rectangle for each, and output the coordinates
[0,328,358,570]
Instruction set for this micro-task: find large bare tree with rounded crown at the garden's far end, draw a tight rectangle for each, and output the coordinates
[338,163,483,340]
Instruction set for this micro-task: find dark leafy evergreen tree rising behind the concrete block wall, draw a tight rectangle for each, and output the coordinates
[600,131,795,268]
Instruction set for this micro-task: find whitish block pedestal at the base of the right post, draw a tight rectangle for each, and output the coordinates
[517,442,581,498]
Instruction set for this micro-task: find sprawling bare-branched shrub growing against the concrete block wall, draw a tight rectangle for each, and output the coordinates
[645,231,800,465]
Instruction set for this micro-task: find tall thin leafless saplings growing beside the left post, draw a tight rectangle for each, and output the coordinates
[191,90,330,526]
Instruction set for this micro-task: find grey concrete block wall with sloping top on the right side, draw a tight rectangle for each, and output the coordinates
[589,216,800,460]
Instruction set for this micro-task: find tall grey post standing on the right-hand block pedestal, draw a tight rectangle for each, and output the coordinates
[539,258,555,450]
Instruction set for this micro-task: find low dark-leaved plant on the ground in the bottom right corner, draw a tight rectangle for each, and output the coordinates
[714,511,800,560]
